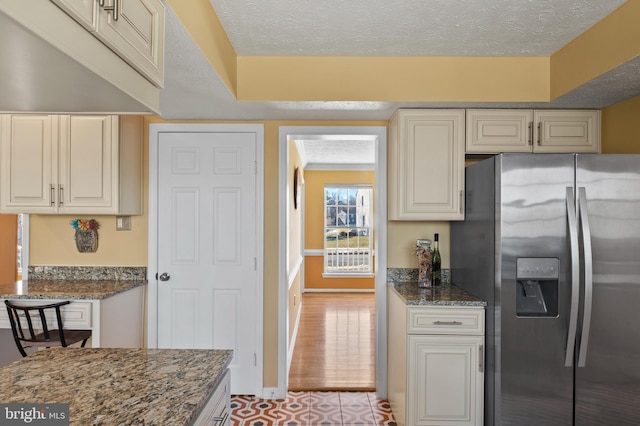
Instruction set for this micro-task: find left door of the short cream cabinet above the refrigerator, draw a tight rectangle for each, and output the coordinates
[466,109,533,154]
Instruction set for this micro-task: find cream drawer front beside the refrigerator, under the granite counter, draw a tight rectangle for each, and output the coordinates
[407,307,484,335]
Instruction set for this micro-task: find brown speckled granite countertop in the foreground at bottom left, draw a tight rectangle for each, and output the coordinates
[0,348,233,426]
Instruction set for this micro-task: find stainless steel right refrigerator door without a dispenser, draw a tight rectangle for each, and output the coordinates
[575,155,640,426]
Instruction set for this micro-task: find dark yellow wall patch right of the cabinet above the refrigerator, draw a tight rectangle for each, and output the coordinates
[602,96,640,154]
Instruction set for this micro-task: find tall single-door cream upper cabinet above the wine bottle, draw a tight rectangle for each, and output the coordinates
[388,109,465,221]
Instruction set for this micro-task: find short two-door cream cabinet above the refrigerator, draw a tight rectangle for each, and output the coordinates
[466,109,600,154]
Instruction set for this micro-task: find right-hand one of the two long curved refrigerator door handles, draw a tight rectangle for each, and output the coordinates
[578,187,593,367]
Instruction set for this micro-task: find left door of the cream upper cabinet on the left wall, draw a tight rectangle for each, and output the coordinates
[0,114,58,213]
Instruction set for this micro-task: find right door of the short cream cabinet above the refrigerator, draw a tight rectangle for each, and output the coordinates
[533,110,600,152]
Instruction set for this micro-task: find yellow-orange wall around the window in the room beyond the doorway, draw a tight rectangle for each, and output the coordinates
[304,170,376,290]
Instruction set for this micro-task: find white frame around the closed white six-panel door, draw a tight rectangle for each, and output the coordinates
[146,123,264,395]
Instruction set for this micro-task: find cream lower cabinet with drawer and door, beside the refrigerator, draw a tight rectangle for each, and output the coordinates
[387,291,484,426]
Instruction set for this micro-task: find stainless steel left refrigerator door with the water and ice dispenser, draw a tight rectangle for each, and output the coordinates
[495,154,575,426]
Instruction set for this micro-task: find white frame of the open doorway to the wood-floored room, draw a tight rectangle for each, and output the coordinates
[277,126,387,398]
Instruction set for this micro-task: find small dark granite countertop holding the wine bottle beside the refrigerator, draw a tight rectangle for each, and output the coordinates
[387,281,487,306]
